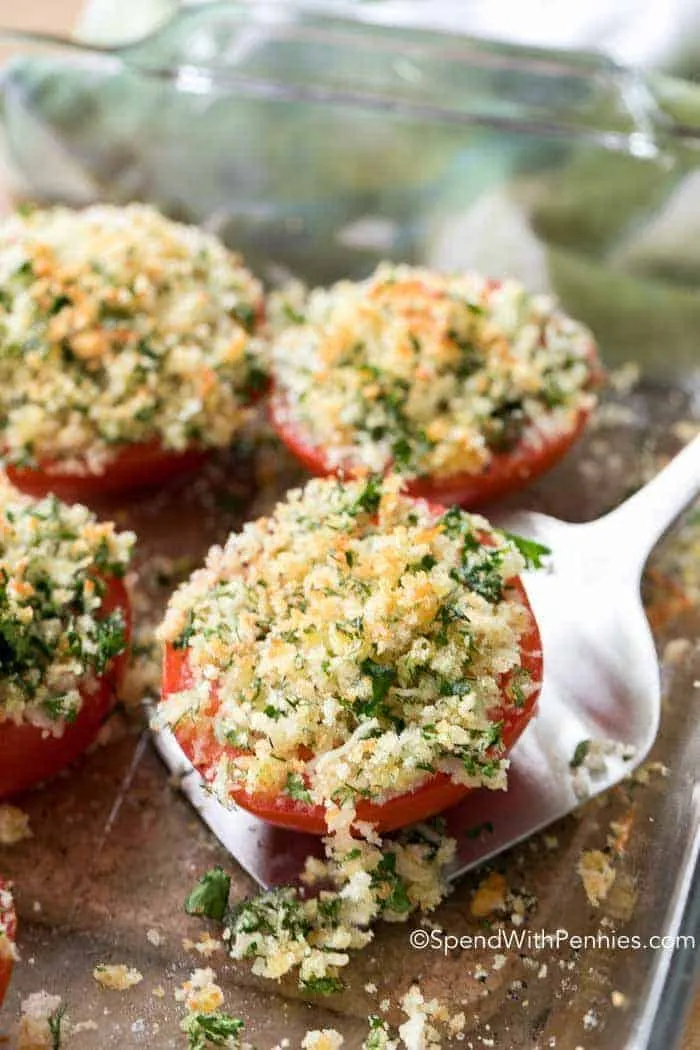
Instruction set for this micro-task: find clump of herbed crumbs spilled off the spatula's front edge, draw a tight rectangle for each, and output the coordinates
[224,806,457,994]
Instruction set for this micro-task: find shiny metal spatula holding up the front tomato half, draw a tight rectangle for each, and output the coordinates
[156,437,700,887]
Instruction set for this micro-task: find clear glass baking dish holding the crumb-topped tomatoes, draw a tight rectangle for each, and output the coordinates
[0,3,700,1050]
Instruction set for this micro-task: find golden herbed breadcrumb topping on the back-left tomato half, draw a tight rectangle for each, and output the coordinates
[0,204,262,474]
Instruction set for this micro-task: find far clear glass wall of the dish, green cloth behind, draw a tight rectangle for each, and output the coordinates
[2,3,700,374]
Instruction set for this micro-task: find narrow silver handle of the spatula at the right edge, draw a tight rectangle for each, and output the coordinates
[596,435,700,571]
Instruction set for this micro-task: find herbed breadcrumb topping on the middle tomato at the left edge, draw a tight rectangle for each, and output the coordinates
[0,475,134,735]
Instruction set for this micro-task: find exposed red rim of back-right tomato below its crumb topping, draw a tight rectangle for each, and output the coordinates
[270,395,590,508]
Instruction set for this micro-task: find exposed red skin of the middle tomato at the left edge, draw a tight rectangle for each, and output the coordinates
[0,576,131,799]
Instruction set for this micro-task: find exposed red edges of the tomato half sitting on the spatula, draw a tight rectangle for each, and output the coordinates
[163,579,543,835]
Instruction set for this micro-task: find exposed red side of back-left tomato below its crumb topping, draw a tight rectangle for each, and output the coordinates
[7,441,209,503]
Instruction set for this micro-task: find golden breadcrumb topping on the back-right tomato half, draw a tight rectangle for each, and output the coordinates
[272,264,597,478]
